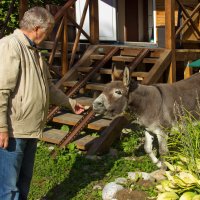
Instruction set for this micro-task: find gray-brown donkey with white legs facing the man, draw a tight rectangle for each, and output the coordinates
[93,67,200,167]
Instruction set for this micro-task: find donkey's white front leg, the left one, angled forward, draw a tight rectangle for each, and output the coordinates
[144,131,161,168]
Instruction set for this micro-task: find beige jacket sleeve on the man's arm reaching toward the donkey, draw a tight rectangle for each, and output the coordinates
[45,63,76,110]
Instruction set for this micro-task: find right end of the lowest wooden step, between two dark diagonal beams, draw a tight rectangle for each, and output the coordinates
[74,135,97,151]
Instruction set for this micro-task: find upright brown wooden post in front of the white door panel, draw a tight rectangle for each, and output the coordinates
[89,0,99,44]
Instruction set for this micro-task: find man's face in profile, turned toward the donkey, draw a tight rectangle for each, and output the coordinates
[34,25,53,45]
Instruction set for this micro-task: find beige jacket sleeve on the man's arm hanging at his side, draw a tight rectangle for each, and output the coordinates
[0,41,20,132]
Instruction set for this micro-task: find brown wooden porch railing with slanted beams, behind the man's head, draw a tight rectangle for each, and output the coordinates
[49,0,98,76]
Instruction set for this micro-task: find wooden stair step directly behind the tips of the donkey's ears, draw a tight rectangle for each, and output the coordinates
[78,67,148,78]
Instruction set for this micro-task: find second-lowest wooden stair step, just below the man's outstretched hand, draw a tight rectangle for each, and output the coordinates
[53,113,111,130]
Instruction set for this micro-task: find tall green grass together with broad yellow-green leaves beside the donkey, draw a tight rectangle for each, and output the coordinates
[157,110,200,200]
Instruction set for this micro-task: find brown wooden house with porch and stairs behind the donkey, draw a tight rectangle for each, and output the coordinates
[15,0,200,153]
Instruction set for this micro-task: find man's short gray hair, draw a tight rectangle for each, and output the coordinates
[19,7,55,31]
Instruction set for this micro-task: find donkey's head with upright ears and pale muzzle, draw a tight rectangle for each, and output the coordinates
[93,67,131,116]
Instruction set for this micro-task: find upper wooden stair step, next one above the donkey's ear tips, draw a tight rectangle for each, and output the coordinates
[90,54,158,64]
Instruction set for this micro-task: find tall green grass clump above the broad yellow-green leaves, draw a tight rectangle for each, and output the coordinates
[167,112,200,178]
